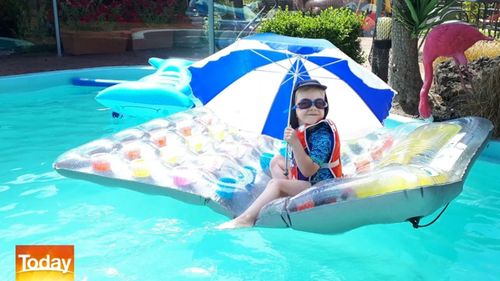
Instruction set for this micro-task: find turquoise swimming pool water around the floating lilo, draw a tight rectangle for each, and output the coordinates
[0,68,500,281]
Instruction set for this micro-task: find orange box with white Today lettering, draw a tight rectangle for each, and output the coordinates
[16,245,75,281]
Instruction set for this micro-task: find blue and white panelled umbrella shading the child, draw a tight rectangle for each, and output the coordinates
[189,33,395,139]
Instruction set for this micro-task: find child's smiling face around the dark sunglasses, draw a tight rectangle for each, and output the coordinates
[295,87,325,125]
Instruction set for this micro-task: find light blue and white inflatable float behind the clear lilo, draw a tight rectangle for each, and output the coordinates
[95,58,197,117]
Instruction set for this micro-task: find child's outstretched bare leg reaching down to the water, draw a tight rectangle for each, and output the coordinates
[219,179,311,229]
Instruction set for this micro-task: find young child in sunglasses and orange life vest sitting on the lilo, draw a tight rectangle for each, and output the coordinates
[218,80,342,229]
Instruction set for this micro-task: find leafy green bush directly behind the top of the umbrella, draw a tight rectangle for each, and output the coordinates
[258,7,365,63]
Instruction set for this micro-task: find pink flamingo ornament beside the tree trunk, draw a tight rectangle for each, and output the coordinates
[418,22,493,119]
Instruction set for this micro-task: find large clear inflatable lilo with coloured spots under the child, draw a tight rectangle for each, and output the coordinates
[54,107,492,233]
